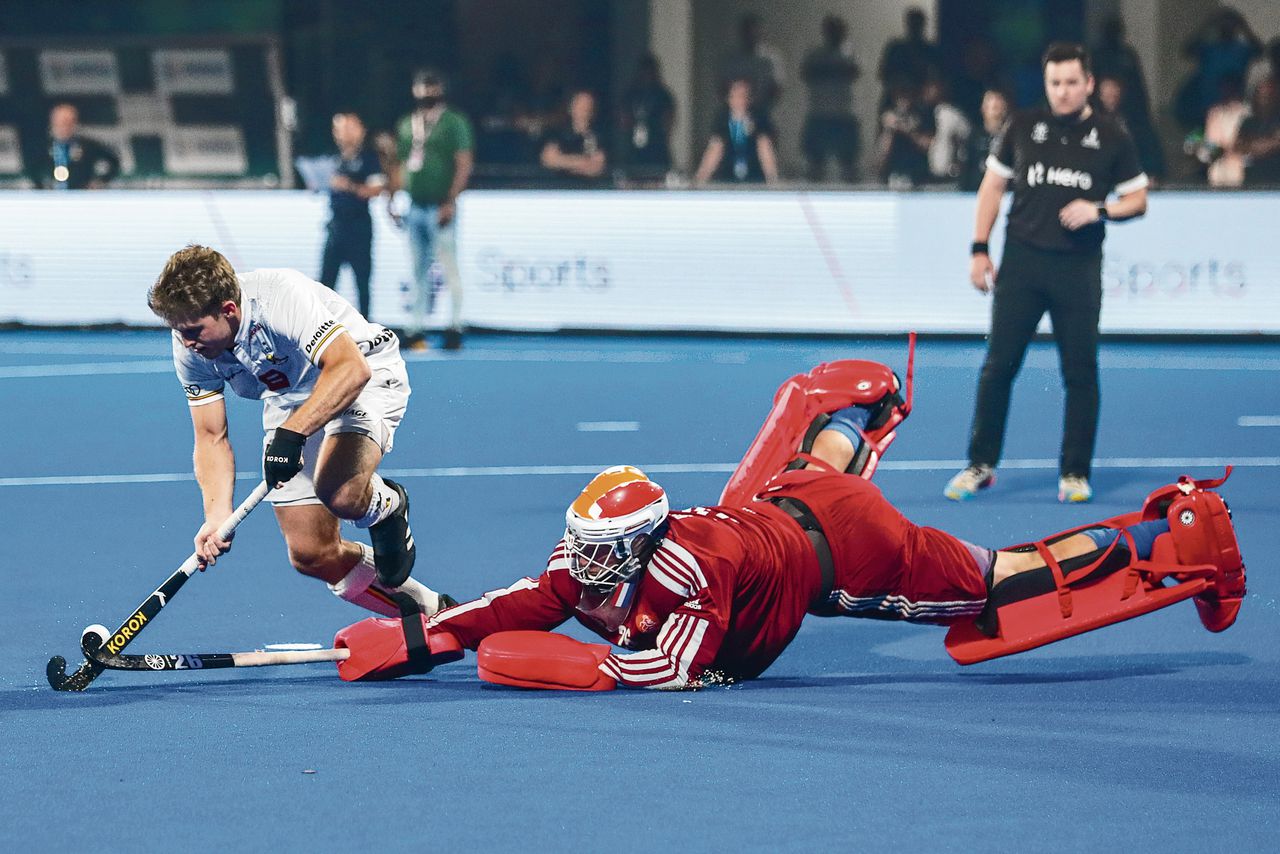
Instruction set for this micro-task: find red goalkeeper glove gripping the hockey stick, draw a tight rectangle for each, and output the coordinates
[333,613,465,682]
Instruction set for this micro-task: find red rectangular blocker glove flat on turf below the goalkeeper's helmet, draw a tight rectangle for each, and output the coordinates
[476,631,617,691]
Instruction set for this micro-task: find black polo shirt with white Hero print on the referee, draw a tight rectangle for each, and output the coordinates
[987,109,1148,254]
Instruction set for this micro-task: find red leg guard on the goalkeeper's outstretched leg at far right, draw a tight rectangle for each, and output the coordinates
[946,469,1244,665]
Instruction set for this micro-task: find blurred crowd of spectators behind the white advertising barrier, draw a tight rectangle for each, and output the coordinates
[24,8,1280,191]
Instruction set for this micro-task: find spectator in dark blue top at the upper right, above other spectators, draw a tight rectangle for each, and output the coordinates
[1175,8,1262,128]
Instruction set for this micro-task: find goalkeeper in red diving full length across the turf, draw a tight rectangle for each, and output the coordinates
[337,362,1244,690]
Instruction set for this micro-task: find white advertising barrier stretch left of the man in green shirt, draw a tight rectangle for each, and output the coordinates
[0,191,408,326]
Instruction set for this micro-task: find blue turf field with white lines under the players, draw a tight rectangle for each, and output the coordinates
[0,332,1280,851]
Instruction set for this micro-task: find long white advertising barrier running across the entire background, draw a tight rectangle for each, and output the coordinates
[0,191,1280,334]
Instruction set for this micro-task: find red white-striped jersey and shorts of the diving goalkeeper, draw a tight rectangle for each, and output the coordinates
[430,471,986,689]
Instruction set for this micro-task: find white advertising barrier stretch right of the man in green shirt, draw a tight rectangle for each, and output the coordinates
[462,192,1280,333]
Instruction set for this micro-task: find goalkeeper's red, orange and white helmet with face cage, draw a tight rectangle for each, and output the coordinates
[564,466,671,593]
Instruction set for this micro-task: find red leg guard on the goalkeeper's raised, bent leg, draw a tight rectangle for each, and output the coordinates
[719,334,915,507]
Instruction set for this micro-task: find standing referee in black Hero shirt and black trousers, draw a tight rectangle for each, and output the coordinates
[943,42,1148,502]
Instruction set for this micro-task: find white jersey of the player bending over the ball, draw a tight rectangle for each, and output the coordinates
[173,269,403,410]
